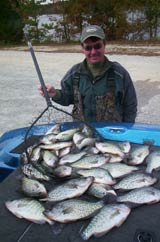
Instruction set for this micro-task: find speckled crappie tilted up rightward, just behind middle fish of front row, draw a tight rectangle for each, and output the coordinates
[40,177,94,202]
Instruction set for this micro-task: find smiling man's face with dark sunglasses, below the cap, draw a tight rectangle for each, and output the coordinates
[82,38,105,64]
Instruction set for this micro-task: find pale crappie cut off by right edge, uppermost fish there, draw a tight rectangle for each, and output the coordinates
[146,151,160,173]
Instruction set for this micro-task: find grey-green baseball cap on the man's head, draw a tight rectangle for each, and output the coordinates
[80,25,105,42]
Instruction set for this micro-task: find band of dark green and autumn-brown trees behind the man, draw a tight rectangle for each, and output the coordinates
[0,0,160,44]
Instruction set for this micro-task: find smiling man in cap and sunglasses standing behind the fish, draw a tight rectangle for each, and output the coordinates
[39,25,137,123]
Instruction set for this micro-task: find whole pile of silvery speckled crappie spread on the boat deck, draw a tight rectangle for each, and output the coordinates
[5,124,160,240]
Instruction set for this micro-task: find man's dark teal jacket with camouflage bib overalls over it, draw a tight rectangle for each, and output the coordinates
[52,58,137,122]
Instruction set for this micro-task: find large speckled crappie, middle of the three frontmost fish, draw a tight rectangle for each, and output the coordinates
[44,199,104,223]
